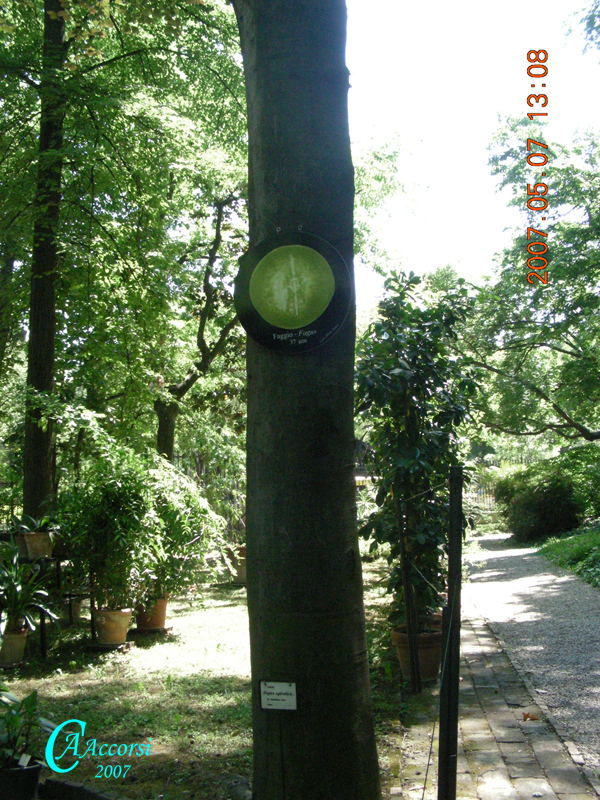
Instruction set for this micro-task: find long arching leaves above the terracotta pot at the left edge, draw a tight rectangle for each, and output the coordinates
[0,544,57,631]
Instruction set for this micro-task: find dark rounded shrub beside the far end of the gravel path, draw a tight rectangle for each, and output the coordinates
[495,462,584,542]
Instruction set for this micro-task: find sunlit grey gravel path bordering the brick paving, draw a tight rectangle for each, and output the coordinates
[463,534,600,770]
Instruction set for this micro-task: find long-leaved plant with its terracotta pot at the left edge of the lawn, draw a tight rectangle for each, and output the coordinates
[0,548,56,666]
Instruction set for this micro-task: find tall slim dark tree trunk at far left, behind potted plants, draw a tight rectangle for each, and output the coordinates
[23,0,68,517]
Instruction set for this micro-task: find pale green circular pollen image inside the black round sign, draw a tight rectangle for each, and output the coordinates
[250,244,335,330]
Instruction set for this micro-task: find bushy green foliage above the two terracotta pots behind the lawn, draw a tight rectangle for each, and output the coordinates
[60,432,223,609]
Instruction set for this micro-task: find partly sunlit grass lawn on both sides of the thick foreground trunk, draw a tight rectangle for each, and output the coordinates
[1,558,408,800]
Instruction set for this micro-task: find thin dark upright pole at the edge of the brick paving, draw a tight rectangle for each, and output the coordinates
[438,467,463,800]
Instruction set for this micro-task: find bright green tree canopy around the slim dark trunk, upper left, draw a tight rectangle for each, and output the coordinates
[0,0,247,504]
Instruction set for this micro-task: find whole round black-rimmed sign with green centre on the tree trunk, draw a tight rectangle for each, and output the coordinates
[234,232,352,353]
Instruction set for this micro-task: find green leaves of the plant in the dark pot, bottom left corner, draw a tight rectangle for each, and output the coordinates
[0,684,56,769]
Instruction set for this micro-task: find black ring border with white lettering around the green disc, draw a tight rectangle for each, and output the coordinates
[233,231,353,353]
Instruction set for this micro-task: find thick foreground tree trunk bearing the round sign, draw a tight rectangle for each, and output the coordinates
[234,0,380,800]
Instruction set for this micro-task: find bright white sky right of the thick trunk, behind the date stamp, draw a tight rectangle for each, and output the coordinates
[347,0,600,307]
